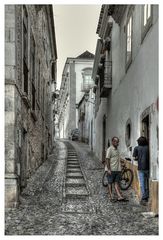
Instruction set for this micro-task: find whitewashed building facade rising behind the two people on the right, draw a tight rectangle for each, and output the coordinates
[92,4,159,213]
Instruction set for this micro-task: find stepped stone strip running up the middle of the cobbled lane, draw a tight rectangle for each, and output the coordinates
[62,142,91,213]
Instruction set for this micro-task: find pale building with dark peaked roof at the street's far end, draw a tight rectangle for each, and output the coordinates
[58,51,94,138]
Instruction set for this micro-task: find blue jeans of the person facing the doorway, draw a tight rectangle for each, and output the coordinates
[138,170,149,200]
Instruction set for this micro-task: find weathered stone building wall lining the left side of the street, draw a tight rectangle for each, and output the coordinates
[5,5,57,207]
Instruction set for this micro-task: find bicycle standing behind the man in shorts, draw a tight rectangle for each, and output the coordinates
[102,158,134,190]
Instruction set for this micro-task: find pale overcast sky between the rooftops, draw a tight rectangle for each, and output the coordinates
[53,5,101,88]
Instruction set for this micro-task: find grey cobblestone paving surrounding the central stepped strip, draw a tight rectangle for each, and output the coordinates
[5,142,158,235]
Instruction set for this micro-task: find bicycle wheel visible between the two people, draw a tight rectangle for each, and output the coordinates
[119,169,133,190]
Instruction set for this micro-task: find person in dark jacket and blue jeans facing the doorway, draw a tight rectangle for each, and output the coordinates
[133,137,149,205]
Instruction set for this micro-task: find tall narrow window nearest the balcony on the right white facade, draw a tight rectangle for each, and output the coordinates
[126,15,132,68]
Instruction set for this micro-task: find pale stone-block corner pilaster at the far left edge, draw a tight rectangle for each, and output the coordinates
[5,5,18,206]
